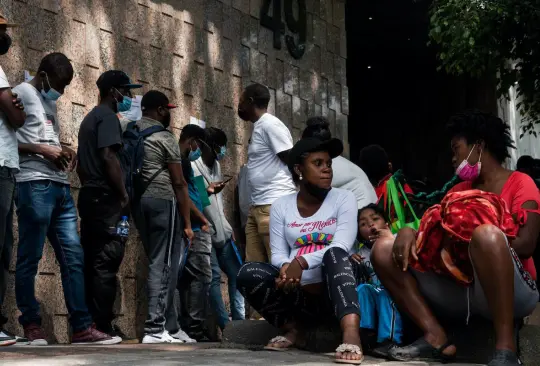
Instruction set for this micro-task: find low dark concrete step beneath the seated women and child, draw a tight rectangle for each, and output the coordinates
[223,318,540,366]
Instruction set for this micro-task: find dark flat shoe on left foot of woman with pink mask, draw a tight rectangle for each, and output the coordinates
[388,338,456,363]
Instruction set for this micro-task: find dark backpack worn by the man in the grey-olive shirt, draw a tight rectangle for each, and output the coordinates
[118,121,167,204]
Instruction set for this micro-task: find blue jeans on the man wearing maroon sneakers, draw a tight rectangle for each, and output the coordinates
[15,180,92,332]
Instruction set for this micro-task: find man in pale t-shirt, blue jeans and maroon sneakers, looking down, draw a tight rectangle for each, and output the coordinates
[14,52,121,346]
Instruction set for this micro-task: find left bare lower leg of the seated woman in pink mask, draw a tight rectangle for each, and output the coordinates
[371,239,456,355]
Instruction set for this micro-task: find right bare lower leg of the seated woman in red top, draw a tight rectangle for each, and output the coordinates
[470,225,516,352]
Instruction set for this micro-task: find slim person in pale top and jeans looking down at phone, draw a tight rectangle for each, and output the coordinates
[192,127,245,330]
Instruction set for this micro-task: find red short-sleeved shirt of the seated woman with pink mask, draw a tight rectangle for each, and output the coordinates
[449,172,540,281]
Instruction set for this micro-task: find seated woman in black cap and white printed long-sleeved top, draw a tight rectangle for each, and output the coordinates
[237,138,363,364]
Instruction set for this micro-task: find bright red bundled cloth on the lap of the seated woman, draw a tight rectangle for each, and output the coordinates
[411,189,519,286]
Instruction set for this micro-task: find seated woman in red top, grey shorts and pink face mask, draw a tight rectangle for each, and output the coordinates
[371,111,540,366]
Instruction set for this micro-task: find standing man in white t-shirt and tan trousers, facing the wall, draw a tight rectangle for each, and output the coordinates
[238,84,296,262]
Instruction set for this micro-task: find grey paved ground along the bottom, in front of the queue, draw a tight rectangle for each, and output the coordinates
[0,344,484,366]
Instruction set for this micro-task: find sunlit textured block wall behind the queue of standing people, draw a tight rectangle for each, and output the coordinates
[0,0,349,343]
